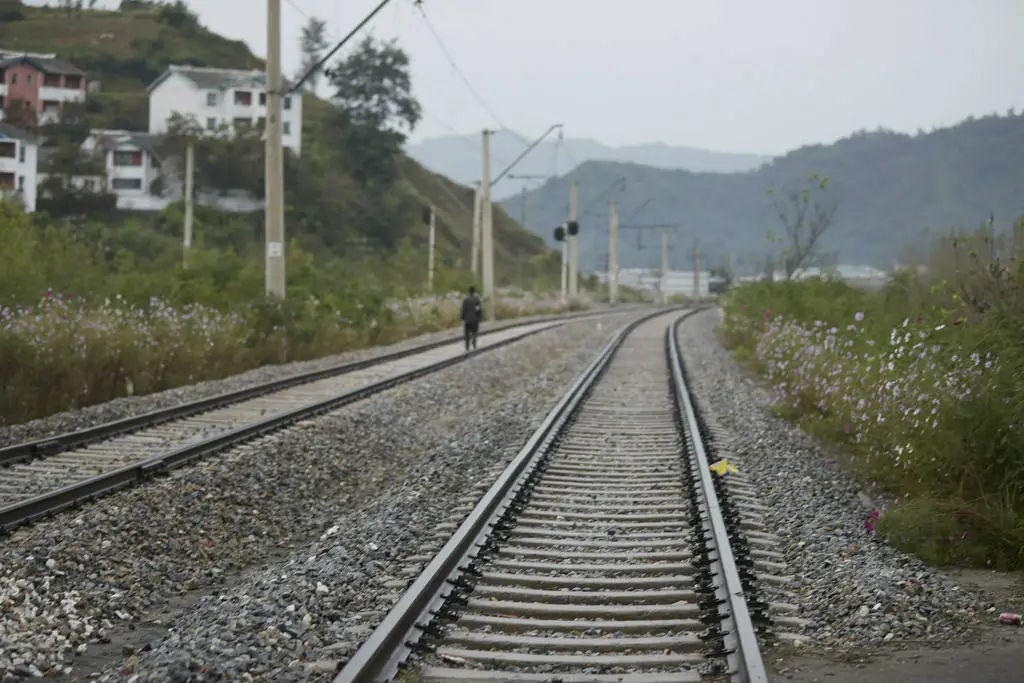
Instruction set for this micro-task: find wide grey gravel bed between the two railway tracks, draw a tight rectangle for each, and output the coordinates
[0,312,637,682]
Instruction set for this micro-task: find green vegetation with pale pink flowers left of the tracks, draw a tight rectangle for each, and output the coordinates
[0,202,586,424]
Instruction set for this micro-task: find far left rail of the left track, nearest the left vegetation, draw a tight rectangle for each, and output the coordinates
[0,308,630,467]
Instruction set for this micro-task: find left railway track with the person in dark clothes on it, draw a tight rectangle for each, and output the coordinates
[0,313,614,532]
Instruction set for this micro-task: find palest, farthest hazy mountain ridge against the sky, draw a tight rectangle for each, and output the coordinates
[406,130,771,198]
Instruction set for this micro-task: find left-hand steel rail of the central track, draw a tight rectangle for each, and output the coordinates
[334,308,671,683]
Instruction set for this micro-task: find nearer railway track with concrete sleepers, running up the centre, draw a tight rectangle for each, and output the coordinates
[335,312,767,683]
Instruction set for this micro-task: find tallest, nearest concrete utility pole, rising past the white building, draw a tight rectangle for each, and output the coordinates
[265,0,285,299]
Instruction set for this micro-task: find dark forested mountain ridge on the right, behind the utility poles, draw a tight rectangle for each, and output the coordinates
[503,112,1024,271]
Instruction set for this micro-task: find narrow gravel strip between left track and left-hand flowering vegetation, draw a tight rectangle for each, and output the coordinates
[0,307,630,447]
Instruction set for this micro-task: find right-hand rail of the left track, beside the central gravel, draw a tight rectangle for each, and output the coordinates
[0,311,638,533]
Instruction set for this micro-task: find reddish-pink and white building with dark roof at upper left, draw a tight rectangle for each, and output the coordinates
[0,50,86,123]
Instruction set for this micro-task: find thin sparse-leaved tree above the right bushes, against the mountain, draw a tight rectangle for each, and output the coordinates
[768,173,839,280]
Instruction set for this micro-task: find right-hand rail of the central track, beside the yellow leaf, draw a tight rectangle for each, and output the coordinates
[667,315,768,683]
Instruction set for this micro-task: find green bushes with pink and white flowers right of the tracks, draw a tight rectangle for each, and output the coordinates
[721,218,1024,568]
